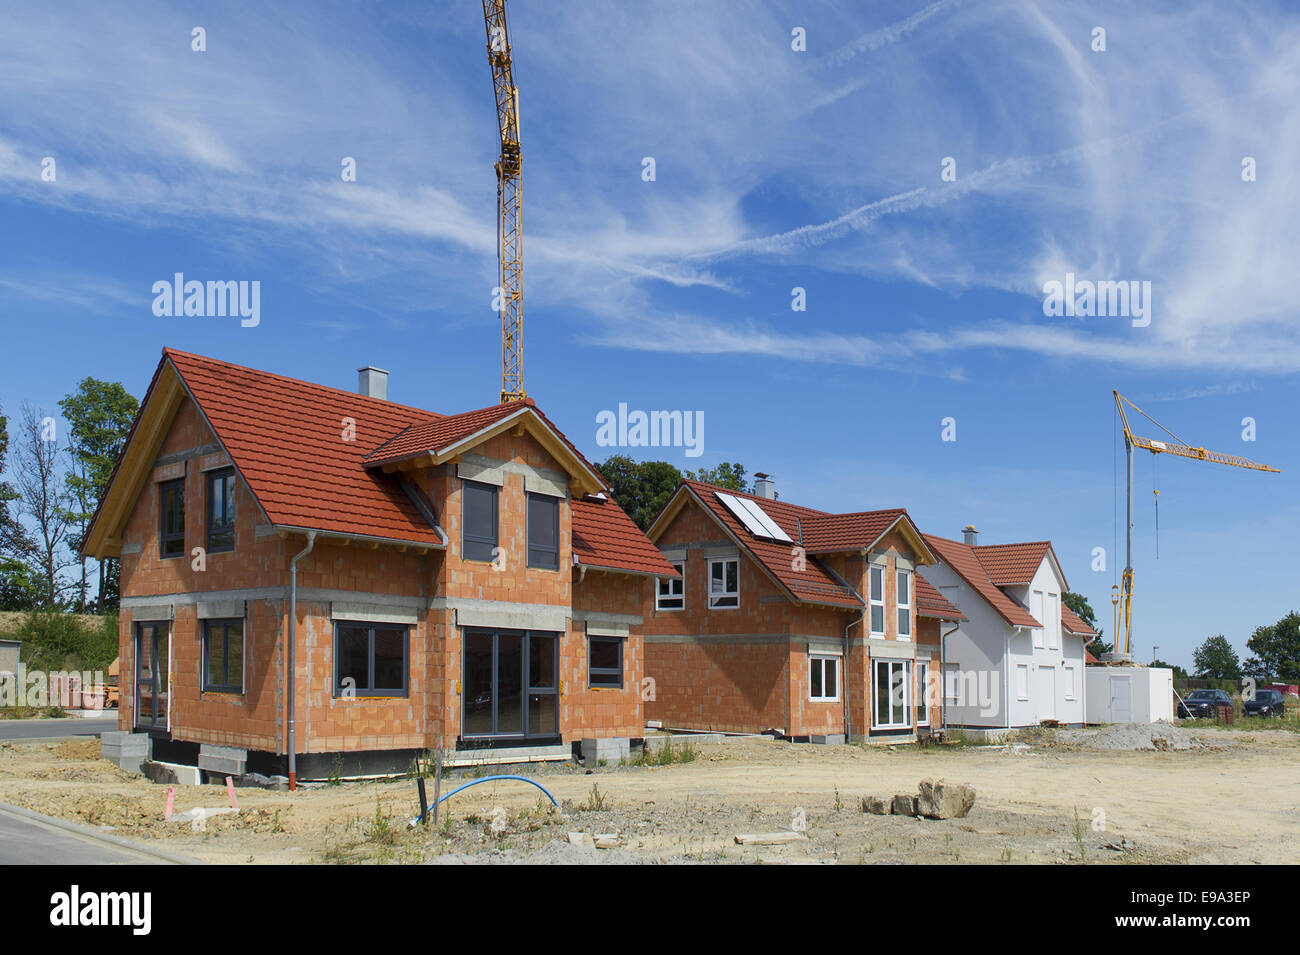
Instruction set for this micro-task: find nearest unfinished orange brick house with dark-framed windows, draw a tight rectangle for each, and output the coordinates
[85,350,675,780]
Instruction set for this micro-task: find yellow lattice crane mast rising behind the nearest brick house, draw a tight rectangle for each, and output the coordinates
[484,0,528,404]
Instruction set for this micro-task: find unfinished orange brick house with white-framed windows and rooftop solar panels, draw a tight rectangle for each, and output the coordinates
[644,478,965,742]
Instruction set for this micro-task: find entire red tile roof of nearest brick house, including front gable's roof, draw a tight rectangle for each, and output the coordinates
[163,348,650,576]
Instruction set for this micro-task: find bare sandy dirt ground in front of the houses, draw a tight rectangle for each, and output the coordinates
[0,729,1300,864]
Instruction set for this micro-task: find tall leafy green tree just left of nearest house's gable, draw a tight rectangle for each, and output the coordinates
[59,377,140,611]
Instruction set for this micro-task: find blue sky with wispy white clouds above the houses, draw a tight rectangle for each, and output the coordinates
[0,0,1300,664]
